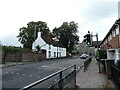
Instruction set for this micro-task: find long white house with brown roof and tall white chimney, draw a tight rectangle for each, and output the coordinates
[32,32,66,59]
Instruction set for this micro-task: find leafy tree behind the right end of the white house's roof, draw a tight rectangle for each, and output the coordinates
[53,21,79,53]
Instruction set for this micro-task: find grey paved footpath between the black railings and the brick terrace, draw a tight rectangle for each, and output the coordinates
[76,58,115,90]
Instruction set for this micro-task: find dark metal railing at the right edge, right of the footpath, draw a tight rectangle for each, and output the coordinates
[111,64,120,90]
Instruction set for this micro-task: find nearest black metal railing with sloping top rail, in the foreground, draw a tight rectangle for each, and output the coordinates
[20,65,76,90]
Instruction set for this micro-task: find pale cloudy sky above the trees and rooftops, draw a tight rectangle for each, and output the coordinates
[0,0,119,46]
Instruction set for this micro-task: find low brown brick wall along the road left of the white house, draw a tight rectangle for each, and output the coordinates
[2,52,46,62]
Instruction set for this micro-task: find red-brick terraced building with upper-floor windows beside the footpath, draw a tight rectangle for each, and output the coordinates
[100,19,120,51]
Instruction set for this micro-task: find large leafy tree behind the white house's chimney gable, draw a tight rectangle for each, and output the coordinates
[17,21,50,49]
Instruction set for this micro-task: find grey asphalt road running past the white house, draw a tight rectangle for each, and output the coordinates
[2,57,82,89]
